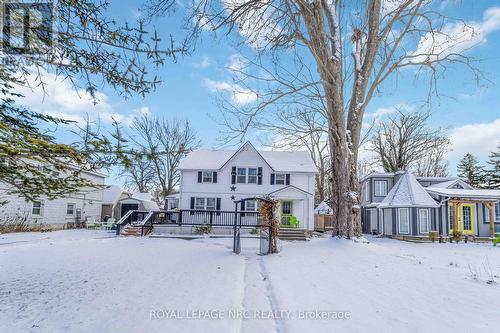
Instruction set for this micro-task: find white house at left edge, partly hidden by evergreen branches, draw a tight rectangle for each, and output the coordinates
[0,167,106,228]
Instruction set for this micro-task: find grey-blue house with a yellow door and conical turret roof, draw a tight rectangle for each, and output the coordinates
[360,172,500,237]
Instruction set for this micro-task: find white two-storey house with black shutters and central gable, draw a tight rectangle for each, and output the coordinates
[179,142,317,230]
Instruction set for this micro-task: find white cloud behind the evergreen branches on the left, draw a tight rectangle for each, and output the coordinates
[16,72,149,125]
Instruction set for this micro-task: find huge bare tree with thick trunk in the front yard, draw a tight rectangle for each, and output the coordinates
[146,0,478,237]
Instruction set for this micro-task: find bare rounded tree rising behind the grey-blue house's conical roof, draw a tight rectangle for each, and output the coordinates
[367,111,450,176]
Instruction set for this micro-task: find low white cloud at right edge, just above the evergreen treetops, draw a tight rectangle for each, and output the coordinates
[447,118,500,169]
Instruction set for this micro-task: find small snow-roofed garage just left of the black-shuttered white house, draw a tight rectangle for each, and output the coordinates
[101,185,159,221]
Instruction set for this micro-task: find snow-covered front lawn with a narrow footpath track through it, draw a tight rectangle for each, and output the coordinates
[0,230,500,333]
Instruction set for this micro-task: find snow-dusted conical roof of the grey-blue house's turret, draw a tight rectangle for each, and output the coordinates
[378,172,439,208]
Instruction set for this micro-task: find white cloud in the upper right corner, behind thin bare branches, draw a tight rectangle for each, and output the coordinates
[408,7,500,63]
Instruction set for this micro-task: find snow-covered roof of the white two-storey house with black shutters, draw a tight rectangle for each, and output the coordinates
[179,142,318,173]
